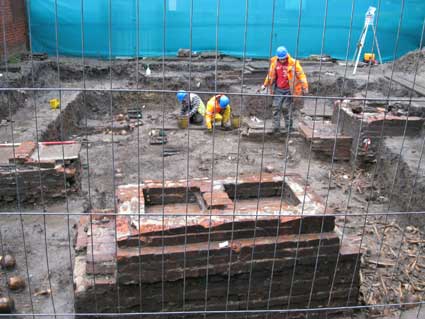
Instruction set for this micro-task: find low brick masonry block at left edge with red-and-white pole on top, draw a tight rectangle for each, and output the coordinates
[0,141,81,203]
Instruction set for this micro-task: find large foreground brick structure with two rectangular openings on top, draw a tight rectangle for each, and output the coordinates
[74,174,360,317]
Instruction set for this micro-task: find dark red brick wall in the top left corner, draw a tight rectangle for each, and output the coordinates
[0,0,28,57]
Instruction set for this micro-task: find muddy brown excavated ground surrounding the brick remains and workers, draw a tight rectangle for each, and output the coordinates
[0,49,425,318]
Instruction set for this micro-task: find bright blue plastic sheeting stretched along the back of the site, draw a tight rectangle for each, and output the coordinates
[28,0,425,60]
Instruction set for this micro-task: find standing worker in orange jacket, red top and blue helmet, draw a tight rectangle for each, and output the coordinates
[261,46,308,133]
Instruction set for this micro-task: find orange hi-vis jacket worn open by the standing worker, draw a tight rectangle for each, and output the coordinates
[264,54,308,95]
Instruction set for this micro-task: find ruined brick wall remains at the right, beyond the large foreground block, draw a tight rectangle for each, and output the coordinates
[298,100,425,165]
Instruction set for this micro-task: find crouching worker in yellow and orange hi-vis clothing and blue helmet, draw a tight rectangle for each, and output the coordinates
[205,94,232,132]
